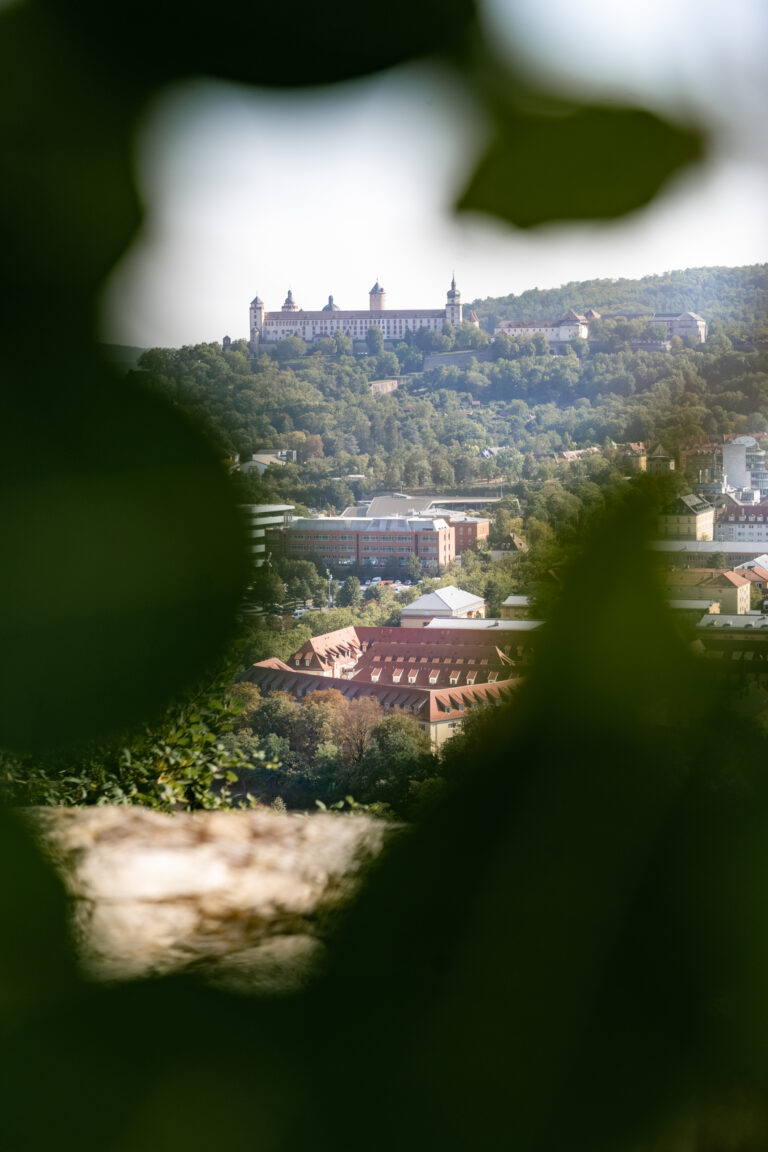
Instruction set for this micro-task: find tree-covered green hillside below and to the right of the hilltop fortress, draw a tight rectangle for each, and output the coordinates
[128,265,768,511]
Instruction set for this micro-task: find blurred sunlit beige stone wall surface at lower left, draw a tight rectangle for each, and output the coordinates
[29,806,391,991]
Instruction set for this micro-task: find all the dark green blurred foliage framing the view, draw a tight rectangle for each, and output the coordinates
[0,0,768,1152]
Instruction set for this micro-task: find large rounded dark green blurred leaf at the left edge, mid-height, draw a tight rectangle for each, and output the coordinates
[0,357,248,750]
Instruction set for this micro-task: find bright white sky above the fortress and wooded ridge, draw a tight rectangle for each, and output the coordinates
[104,0,768,347]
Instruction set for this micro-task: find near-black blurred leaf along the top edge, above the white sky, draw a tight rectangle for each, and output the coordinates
[37,0,474,88]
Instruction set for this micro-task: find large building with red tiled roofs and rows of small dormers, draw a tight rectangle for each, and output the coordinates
[245,626,520,748]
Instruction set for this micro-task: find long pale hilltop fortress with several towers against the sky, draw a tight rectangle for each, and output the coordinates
[251,279,480,351]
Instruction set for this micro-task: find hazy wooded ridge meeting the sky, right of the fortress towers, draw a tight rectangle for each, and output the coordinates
[470,264,768,331]
